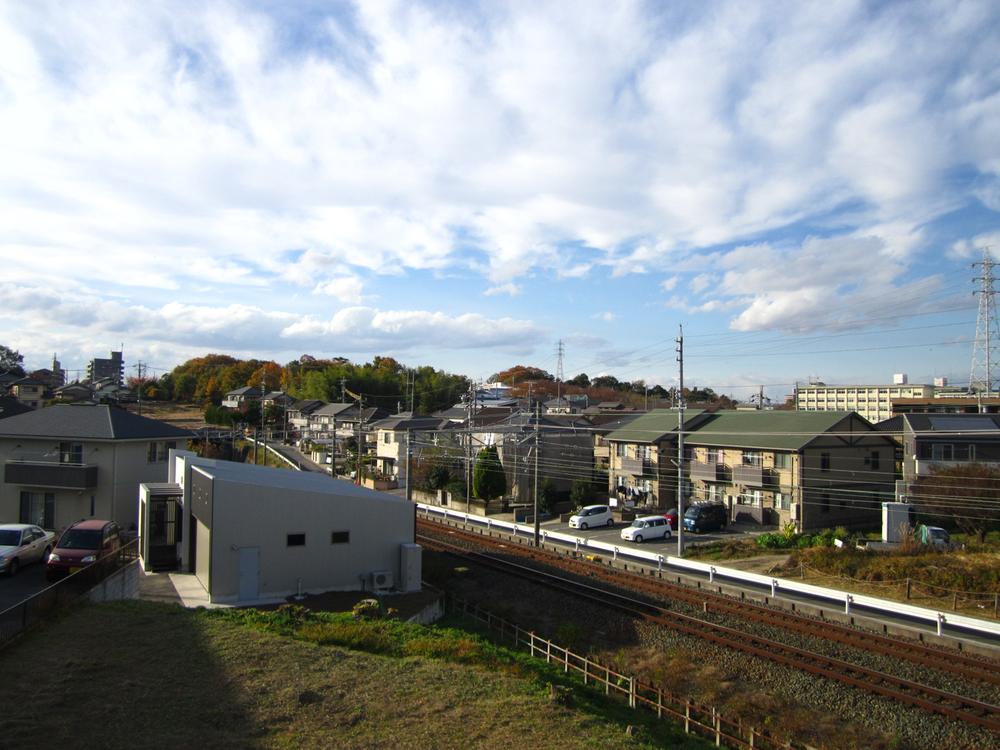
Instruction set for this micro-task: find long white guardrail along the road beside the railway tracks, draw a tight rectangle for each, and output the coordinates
[416,503,1000,639]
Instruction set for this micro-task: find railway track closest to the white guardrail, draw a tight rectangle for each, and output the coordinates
[421,521,1000,686]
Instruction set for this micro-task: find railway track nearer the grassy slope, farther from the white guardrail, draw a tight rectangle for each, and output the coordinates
[417,530,1000,733]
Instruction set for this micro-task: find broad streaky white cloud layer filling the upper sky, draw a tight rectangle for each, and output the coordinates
[0,2,988,291]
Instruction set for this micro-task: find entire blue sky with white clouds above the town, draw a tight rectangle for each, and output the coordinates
[0,0,1000,400]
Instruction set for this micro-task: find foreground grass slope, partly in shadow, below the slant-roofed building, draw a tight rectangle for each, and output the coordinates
[0,601,708,748]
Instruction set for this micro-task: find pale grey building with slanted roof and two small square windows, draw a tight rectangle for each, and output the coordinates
[139,452,421,603]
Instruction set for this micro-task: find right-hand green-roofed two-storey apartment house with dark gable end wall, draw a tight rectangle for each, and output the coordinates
[684,410,895,531]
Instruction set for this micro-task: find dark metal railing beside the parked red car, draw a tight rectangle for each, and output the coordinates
[0,539,139,649]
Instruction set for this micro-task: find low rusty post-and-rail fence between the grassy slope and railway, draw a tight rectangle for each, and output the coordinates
[445,595,800,750]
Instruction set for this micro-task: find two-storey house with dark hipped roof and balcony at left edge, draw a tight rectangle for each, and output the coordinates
[0,404,191,529]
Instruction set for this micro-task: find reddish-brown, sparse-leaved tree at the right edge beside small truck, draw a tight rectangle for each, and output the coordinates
[912,463,1000,543]
